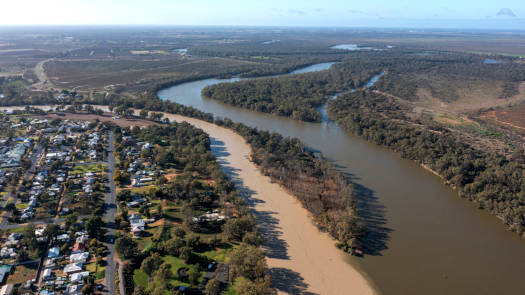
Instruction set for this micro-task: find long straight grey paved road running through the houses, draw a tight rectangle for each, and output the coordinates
[104,131,117,294]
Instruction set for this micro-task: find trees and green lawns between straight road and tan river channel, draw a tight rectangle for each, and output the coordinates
[115,123,274,295]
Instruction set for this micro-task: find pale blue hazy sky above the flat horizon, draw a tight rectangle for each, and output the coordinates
[0,0,525,30]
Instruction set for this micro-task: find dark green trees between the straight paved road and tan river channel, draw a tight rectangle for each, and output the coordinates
[111,122,275,295]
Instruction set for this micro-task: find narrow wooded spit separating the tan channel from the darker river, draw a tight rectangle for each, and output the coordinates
[81,95,366,252]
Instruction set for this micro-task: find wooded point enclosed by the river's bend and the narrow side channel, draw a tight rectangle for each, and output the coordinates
[202,62,380,122]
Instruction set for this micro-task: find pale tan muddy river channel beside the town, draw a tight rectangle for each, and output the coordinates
[0,106,376,295]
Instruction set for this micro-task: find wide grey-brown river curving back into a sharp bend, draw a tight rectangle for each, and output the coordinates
[158,63,525,294]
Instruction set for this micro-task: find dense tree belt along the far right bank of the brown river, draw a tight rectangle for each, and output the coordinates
[328,91,525,235]
